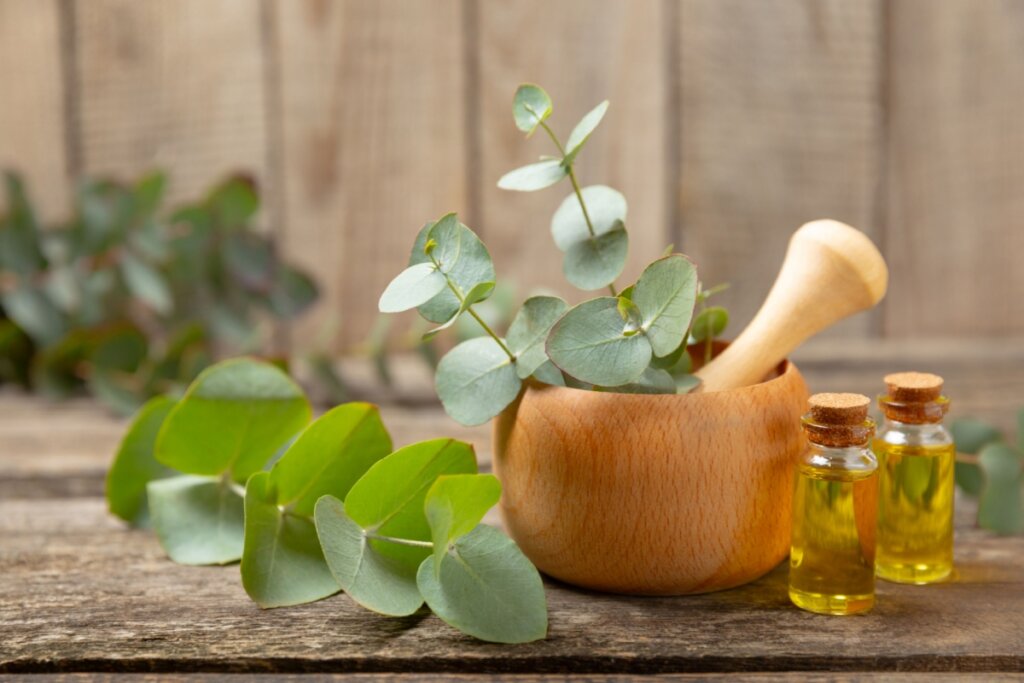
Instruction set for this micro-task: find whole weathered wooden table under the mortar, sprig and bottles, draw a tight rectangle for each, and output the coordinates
[0,345,1024,681]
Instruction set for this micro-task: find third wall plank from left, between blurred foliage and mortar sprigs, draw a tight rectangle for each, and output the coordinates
[273,0,467,347]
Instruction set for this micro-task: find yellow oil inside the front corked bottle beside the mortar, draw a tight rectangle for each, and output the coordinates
[790,463,878,614]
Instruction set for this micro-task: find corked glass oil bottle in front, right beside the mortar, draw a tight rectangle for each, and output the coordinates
[790,393,879,614]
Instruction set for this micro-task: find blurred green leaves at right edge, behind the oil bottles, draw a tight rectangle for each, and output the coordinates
[951,409,1024,533]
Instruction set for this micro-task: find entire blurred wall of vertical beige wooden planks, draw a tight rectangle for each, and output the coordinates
[0,0,1024,347]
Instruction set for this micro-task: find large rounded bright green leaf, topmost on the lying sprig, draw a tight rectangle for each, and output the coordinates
[157,358,310,482]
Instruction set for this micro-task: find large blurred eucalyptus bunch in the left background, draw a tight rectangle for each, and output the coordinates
[0,173,319,414]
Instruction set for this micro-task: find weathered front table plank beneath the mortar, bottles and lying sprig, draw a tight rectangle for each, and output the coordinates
[0,499,1024,674]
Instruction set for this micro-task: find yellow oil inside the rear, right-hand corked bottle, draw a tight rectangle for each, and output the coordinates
[873,439,956,584]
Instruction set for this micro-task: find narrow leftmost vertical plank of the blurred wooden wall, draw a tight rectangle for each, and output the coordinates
[0,0,70,220]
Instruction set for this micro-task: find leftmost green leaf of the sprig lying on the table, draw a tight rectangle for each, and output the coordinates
[106,396,174,526]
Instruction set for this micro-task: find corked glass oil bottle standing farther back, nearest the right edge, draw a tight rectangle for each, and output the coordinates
[872,373,956,584]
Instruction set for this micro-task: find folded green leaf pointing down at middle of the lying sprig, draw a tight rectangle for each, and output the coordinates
[242,472,340,607]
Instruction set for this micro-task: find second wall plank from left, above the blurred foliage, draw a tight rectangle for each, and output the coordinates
[71,0,267,214]
